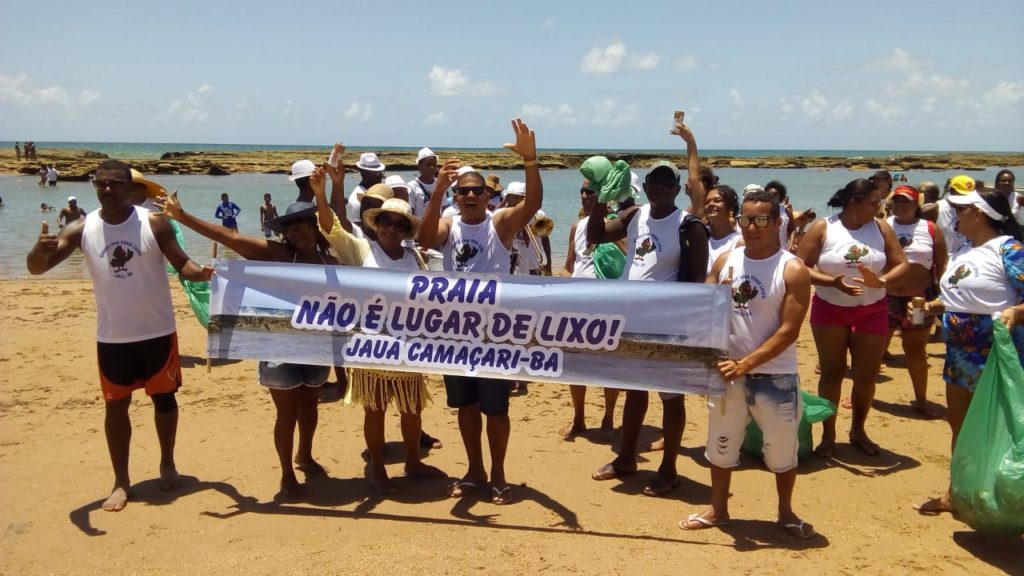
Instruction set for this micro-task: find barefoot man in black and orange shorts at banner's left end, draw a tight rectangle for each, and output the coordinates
[26,160,213,511]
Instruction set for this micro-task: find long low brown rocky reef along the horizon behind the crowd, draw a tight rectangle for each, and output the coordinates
[0,148,1024,181]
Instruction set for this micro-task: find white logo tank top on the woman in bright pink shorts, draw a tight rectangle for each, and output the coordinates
[814,214,886,306]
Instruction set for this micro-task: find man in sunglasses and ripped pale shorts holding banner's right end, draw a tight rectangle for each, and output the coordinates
[679,191,815,538]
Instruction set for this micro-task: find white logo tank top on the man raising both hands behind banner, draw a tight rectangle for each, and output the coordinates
[440,212,512,274]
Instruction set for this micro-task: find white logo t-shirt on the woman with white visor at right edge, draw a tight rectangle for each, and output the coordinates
[939,236,1020,314]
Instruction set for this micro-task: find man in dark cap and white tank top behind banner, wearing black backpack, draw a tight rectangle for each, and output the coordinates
[587,120,708,496]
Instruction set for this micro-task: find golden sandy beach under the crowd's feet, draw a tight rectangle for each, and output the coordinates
[0,279,1024,576]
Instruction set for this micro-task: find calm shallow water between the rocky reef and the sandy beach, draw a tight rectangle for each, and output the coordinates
[0,165,1024,279]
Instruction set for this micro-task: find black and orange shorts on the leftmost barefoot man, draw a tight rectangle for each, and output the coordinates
[96,332,181,402]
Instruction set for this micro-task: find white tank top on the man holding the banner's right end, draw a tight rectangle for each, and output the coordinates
[719,247,797,374]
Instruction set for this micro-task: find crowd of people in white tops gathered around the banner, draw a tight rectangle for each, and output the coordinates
[27,119,1024,538]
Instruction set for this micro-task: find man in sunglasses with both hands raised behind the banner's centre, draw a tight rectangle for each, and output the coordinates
[419,118,544,504]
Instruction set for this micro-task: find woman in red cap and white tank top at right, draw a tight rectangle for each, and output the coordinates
[886,186,948,418]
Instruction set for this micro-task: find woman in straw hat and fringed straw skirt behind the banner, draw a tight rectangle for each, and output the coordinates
[309,168,446,487]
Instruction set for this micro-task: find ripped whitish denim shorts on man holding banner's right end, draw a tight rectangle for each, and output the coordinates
[705,374,804,474]
